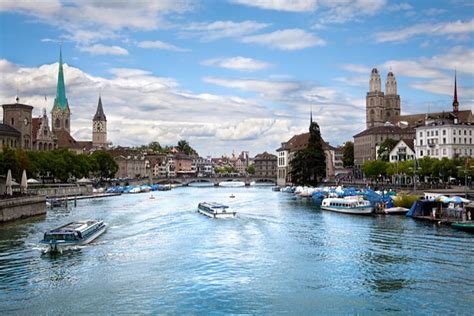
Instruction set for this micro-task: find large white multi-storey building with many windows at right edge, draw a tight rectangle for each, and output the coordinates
[415,117,474,159]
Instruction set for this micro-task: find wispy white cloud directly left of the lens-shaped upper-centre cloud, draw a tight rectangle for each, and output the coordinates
[181,20,270,42]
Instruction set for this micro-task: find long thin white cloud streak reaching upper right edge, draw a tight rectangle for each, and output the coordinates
[375,19,474,43]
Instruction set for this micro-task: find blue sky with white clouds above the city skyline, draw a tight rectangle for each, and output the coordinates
[0,0,474,156]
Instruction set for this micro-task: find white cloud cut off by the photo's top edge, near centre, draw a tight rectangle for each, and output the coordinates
[232,0,318,12]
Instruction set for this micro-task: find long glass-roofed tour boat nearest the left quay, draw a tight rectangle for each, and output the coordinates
[40,220,107,251]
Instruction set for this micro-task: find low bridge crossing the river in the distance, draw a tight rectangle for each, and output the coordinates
[120,177,276,186]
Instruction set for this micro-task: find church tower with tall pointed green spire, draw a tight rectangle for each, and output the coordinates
[51,48,71,133]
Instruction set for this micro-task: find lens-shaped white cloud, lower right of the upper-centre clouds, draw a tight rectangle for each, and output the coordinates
[241,29,326,50]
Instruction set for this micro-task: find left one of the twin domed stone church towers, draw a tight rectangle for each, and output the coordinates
[365,68,385,128]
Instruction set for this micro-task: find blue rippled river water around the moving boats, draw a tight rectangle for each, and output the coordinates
[0,187,474,315]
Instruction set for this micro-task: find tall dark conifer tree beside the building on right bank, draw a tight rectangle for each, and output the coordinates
[290,122,326,185]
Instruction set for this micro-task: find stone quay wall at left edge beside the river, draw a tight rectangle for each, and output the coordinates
[0,196,46,223]
